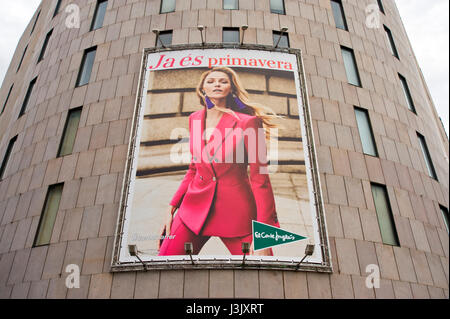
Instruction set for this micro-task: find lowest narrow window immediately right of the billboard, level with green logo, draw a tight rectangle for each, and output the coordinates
[372,184,400,246]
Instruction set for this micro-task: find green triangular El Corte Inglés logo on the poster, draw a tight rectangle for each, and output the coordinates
[253,221,307,251]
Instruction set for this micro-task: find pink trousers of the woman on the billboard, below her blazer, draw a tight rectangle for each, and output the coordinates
[159,214,253,256]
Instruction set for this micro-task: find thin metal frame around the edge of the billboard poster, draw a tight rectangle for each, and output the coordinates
[111,43,333,273]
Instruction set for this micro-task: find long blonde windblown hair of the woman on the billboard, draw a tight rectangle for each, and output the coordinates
[197,67,281,137]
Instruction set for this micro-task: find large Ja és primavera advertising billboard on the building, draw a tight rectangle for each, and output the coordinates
[112,46,331,271]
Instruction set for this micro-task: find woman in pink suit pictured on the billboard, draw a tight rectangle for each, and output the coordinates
[159,67,279,256]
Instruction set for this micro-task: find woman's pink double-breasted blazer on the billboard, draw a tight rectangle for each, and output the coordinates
[170,109,279,238]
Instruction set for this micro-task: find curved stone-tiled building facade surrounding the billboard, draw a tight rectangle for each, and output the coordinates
[0,0,449,299]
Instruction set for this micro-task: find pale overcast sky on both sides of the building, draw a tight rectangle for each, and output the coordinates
[0,0,449,134]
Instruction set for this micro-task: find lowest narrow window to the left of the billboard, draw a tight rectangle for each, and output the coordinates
[33,184,64,247]
